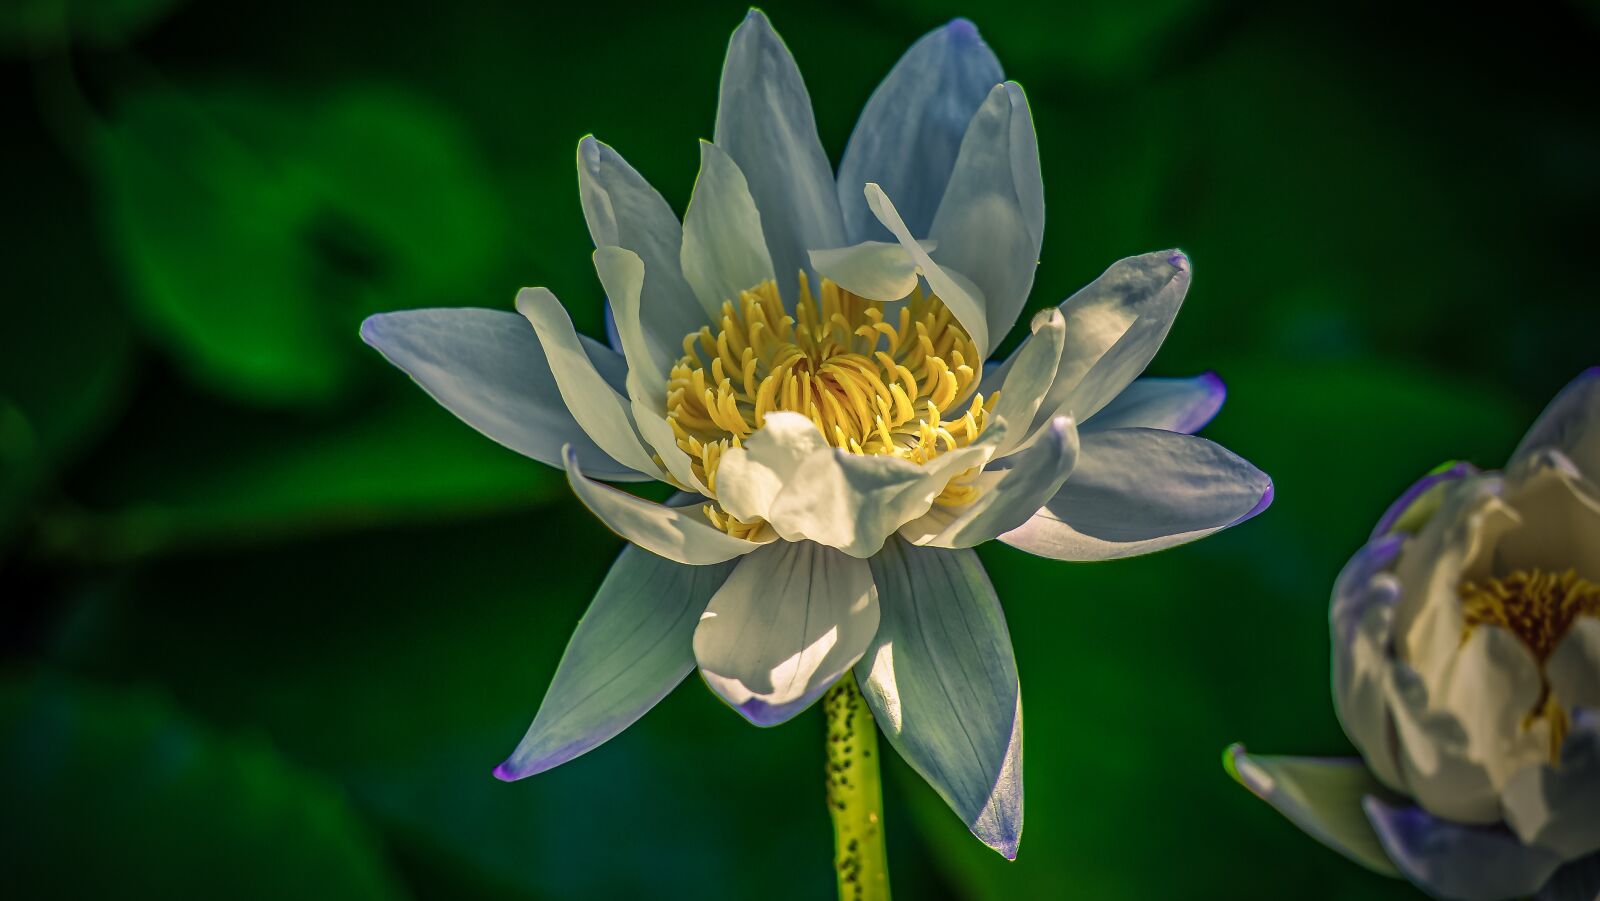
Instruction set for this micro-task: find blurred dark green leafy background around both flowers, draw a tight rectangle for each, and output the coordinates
[0,0,1600,899]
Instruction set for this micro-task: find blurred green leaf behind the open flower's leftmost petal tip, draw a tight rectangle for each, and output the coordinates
[42,387,566,560]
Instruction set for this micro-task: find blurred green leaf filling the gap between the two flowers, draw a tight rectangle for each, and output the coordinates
[891,362,1520,901]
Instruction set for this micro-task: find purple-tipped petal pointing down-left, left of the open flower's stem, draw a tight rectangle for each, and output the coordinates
[494,544,733,783]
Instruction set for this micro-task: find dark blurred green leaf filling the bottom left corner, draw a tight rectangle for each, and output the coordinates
[0,677,402,899]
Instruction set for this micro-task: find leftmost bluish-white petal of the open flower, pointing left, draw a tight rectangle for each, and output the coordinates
[362,309,654,482]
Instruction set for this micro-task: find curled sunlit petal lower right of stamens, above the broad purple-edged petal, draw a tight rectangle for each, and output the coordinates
[901,416,1078,547]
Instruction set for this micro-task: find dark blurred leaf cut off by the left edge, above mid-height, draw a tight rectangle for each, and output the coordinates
[0,88,133,544]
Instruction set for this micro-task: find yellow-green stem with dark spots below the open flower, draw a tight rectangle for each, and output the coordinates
[822,672,890,901]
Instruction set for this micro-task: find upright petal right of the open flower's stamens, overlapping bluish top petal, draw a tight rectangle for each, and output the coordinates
[928,82,1045,341]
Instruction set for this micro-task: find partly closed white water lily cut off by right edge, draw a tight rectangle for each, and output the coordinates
[1230,370,1600,901]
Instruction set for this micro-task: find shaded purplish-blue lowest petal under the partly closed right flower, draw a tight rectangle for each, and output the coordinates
[1365,797,1562,901]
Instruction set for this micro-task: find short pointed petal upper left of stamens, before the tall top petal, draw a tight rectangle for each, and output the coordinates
[682,141,773,316]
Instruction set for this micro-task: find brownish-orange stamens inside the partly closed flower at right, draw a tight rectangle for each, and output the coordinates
[1461,568,1600,763]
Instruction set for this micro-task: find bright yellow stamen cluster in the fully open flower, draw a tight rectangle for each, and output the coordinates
[667,274,997,538]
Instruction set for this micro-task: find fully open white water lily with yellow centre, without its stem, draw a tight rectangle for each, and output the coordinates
[362,13,1270,856]
